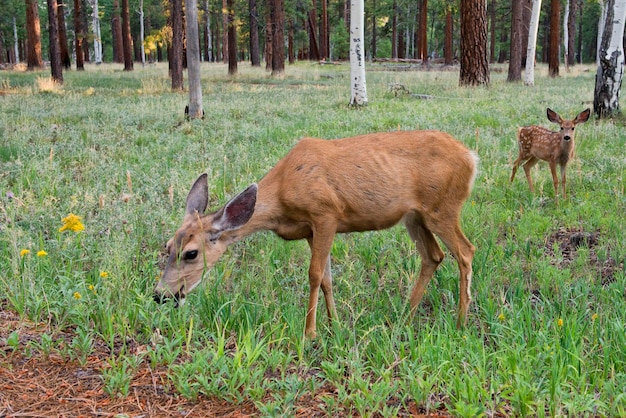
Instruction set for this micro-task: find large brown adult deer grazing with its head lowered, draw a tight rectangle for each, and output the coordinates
[155,131,478,338]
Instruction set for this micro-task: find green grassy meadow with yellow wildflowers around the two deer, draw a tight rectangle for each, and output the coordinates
[0,63,626,417]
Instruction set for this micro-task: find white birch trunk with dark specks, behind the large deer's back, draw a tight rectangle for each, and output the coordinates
[350,0,367,106]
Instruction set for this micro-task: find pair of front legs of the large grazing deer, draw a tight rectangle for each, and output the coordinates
[304,227,335,338]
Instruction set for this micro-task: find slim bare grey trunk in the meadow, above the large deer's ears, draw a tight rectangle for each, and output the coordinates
[185,0,204,119]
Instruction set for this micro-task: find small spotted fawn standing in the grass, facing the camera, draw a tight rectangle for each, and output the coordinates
[511,108,591,200]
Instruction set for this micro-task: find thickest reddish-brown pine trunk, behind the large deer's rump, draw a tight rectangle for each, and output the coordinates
[459,0,489,86]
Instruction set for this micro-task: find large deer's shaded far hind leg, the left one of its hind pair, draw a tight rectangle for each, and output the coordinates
[404,214,444,314]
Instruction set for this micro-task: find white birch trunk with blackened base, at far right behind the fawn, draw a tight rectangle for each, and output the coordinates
[593,0,626,118]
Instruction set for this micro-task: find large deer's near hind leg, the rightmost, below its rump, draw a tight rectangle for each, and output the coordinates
[428,212,476,328]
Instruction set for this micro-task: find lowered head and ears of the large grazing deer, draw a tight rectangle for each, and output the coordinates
[154,174,257,305]
